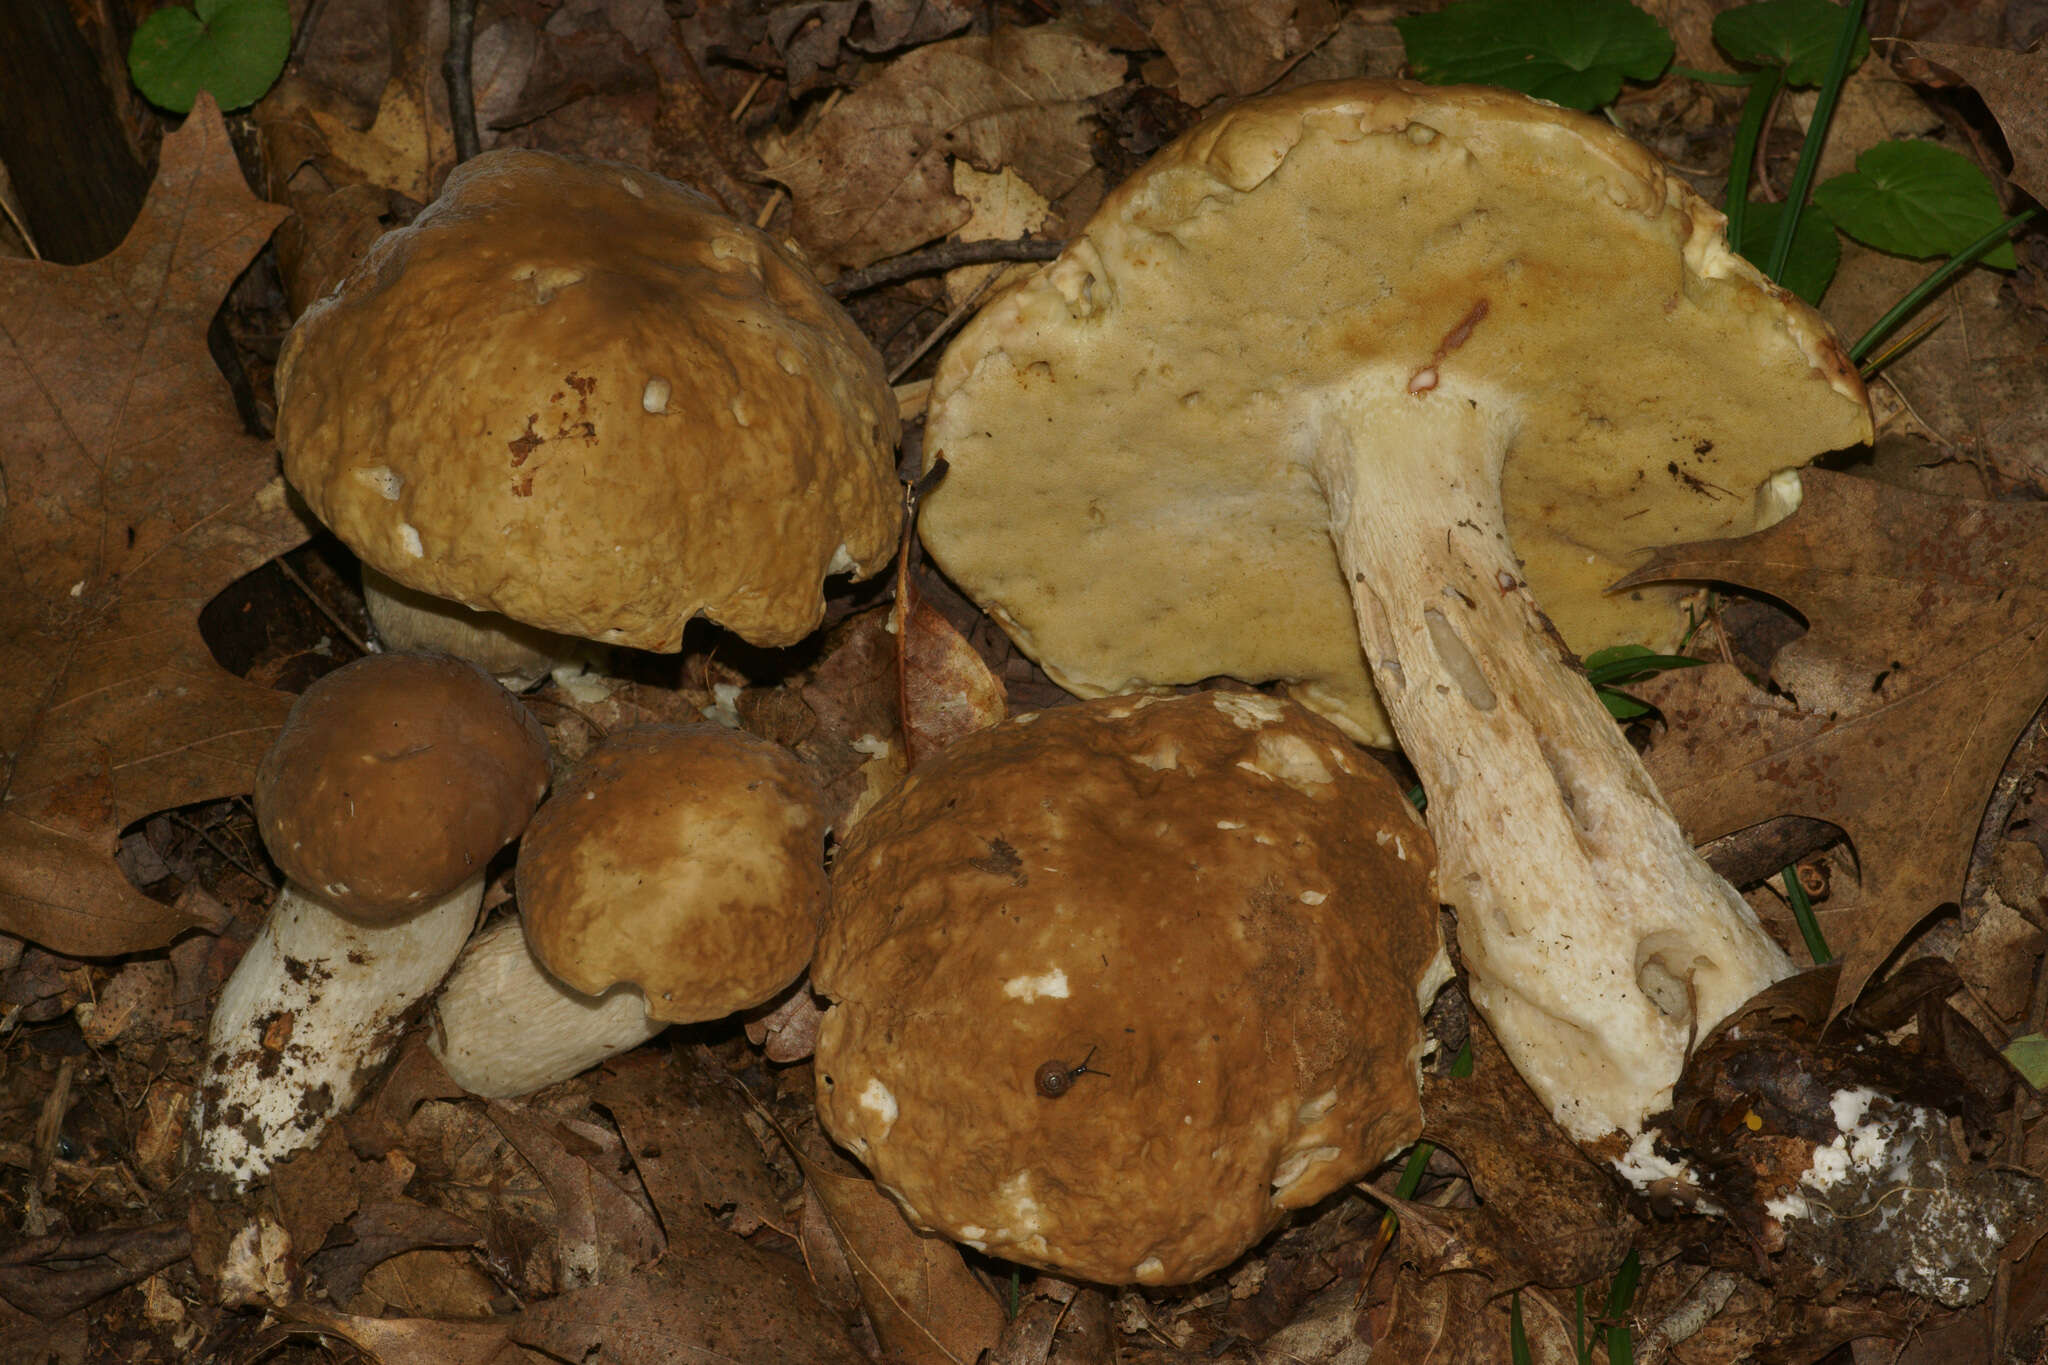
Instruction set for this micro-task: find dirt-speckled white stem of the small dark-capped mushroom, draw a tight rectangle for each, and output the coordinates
[190,874,483,1189]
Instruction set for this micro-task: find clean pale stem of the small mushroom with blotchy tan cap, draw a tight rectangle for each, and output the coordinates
[428,919,668,1099]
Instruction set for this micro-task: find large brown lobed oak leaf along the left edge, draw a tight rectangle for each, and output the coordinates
[0,98,305,956]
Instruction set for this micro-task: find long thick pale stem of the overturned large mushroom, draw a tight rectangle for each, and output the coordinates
[1311,384,1792,1140]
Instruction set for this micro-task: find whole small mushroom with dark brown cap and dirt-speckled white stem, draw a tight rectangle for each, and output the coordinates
[193,655,547,1189]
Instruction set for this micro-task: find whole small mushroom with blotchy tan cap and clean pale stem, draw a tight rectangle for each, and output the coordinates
[430,724,827,1095]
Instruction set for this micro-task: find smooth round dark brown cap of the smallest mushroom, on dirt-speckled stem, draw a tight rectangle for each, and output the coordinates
[256,655,547,925]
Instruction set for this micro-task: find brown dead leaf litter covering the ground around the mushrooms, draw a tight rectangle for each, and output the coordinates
[12,0,2048,1363]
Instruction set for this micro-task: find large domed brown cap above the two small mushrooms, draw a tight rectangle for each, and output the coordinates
[276,149,901,651]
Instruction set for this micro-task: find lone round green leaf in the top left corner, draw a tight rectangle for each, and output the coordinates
[129,0,291,115]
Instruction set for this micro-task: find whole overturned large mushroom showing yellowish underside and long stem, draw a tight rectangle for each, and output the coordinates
[920,82,1870,1146]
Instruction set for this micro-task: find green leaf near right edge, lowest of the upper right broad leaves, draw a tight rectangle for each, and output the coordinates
[1812,141,2019,270]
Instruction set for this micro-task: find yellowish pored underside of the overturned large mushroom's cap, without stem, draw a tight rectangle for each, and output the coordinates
[920,80,1870,743]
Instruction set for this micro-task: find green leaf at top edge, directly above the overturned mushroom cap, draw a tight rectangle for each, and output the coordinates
[1395,0,1673,108]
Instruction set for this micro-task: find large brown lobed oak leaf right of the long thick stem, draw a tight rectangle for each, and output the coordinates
[1620,471,2048,1009]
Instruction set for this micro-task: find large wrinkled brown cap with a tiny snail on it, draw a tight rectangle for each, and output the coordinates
[811,692,1450,1283]
